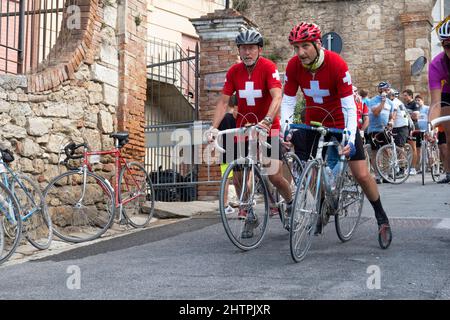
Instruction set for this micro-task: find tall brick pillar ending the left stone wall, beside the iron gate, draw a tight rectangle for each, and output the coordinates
[117,0,147,162]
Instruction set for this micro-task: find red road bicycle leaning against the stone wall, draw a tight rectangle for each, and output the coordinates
[44,132,154,243]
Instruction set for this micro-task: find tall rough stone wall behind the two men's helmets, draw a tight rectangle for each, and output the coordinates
[237,0,436,100]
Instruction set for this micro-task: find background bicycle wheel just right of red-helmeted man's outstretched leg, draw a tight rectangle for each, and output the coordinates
[375,144,411,184]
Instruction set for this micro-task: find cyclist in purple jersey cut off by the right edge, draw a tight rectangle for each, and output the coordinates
[428,16,450,183]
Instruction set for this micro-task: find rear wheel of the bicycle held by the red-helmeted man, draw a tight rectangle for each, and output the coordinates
[334,167,364,242]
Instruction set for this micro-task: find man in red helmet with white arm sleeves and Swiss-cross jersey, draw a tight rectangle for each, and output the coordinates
[281,22,392,249]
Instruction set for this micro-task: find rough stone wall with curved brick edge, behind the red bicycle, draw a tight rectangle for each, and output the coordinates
[0,0,146,183]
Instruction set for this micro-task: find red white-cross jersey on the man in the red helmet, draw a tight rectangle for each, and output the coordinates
[284,50,353,128]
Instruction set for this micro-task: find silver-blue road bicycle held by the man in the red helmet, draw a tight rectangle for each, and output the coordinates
[289,121,364,262]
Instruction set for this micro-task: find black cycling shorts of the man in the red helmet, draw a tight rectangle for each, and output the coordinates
[291,129,365,161]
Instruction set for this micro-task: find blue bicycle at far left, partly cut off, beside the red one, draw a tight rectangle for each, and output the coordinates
[0,150,53,256]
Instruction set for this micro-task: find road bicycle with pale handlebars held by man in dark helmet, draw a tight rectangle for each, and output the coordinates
[215,126,302,250]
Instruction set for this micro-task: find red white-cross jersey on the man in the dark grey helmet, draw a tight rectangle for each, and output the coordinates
[222,57,281,129]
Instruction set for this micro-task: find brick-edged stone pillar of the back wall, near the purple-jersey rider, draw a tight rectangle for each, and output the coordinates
[400,10,433,102]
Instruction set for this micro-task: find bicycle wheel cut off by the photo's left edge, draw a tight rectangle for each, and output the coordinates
[0,182,22,264]
